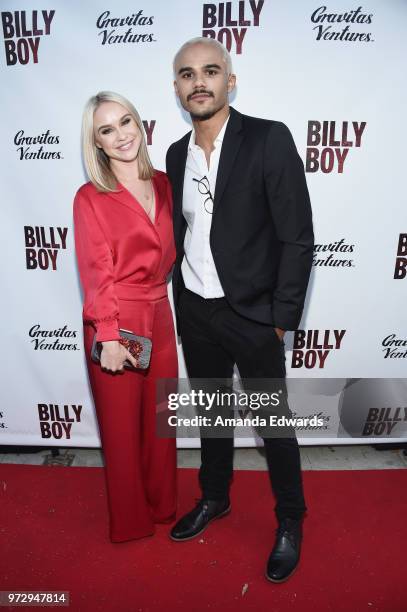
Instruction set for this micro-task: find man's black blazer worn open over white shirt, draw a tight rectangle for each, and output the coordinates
[166,108,314,330]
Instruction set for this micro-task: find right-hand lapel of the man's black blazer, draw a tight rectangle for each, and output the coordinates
[213,107,243,214]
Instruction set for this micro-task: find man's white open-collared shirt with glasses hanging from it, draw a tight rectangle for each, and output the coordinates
[181,117,229,298]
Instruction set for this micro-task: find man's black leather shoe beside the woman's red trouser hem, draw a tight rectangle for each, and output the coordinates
[170,498,230,542]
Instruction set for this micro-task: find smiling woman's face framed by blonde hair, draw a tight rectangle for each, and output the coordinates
[93,102,141,162]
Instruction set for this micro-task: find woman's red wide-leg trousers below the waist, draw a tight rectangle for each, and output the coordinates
[84,297,178,542]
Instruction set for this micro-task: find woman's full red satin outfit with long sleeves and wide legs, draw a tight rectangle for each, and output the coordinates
[74,171,178,542]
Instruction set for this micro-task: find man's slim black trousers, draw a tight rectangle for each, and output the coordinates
[178,289,306,520]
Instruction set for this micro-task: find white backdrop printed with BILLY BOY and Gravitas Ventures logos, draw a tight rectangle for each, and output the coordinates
[0,0,407,446]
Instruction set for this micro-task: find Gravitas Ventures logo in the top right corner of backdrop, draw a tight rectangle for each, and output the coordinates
[311,6,373,42]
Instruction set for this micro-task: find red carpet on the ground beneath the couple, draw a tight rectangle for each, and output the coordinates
[0,464,407,612]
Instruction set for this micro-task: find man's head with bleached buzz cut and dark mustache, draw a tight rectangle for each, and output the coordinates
[174,43,236,121]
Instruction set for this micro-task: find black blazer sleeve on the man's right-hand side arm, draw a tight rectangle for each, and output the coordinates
[264,122,314,330]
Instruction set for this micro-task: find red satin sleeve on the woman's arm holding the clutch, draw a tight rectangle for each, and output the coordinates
[74,190,120,342]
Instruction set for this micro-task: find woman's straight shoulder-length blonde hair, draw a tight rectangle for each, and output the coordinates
[82,91,154,191]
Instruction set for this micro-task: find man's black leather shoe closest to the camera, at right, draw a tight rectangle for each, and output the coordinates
[266,518,302,582]
